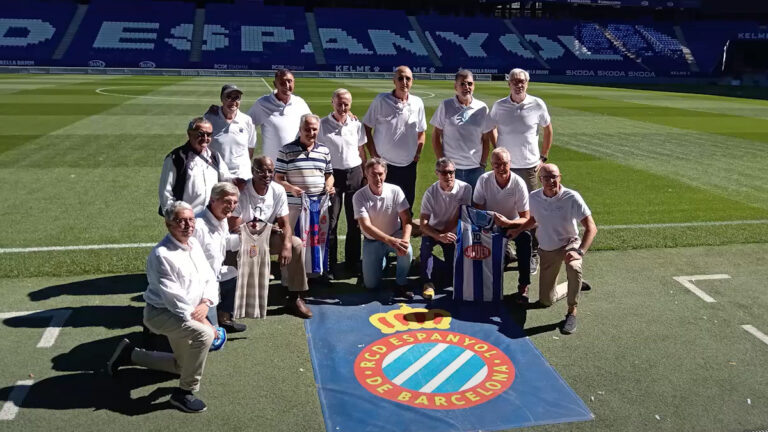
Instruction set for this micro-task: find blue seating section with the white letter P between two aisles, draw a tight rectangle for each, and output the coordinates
[200,3,316,70]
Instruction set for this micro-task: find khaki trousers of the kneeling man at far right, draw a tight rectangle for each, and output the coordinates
[539,246,582,307]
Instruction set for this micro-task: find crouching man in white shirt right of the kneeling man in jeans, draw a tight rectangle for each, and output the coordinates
[419,157,472,300]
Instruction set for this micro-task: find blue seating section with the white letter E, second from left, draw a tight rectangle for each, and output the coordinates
[61,0,194,68]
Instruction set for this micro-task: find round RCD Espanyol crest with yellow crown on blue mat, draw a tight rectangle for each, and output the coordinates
[355,305,515,410]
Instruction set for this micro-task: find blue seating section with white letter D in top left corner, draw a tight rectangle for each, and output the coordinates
[0,0,77,66]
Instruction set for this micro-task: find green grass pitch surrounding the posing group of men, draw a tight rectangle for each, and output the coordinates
[0,75,768,431]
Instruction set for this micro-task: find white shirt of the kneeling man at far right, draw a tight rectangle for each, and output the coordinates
[530,185,592,251]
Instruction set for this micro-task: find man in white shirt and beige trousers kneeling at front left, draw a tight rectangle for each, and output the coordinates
[107,201,219,412]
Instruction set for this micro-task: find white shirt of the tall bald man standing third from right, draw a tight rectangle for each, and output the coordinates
[363,92,427,166]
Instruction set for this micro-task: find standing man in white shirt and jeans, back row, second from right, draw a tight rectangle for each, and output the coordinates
[429,69,493,188]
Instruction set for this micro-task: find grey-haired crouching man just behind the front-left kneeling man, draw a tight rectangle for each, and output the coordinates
[195,182,246,333]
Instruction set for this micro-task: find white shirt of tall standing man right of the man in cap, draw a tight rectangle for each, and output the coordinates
[248,92,311,160]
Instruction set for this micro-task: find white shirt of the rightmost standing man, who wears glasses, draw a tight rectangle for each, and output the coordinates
[488,95,550,168]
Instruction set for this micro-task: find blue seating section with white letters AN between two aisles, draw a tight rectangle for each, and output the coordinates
[315,8,435,72]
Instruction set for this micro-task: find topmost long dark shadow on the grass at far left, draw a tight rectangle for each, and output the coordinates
[28,273,147,301]
